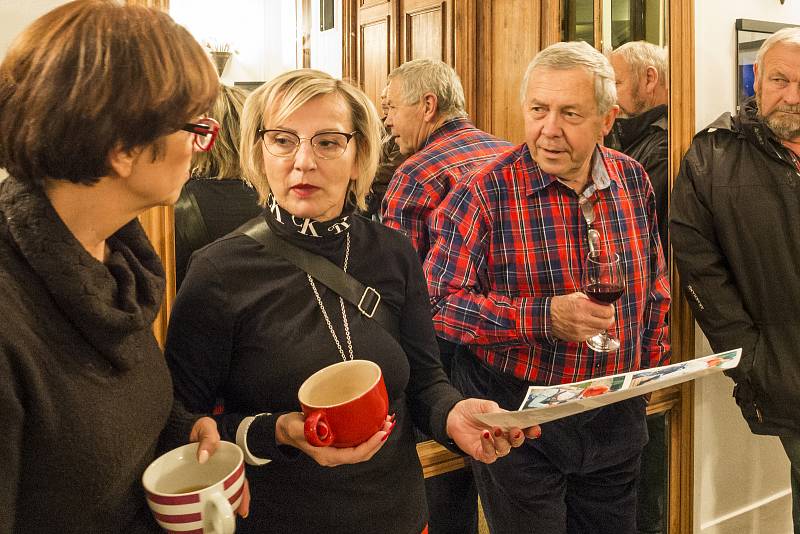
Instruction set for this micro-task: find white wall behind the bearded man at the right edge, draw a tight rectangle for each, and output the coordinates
[694,0,800,534]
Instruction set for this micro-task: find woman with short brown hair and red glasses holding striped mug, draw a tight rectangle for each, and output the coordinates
[0,0,242,534]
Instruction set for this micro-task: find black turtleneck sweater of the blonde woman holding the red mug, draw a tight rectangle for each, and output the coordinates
[166,204,461,534]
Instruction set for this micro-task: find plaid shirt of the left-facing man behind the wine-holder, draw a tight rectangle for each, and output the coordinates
[382,117,511,261]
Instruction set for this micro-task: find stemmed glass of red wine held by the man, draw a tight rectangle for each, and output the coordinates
[583,252,625,352]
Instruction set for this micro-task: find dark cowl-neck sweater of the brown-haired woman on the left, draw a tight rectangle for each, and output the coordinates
[0,177,175,534]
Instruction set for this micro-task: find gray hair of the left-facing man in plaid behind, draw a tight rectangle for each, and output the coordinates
[389,59,467,118]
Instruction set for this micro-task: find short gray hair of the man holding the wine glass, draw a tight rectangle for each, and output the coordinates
[520,41,617,115]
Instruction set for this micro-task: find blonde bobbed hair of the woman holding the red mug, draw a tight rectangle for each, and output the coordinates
[239,69,381,210]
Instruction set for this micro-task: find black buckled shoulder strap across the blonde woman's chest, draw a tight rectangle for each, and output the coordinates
[236,216,399,338]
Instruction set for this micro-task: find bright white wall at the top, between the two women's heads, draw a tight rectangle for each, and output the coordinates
[169,0,296,85]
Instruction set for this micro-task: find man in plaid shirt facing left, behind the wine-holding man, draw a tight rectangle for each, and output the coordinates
[382,59,511,534]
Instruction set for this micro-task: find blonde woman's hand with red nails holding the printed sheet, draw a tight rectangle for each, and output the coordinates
[447,399,542,464]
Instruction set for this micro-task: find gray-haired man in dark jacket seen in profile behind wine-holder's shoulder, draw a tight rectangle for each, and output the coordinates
[605,41,669,252]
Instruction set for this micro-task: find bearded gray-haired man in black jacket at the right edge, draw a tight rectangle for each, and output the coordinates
[670,28,800,534]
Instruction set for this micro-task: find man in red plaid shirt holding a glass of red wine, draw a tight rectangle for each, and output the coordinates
[425,42,670,534]
